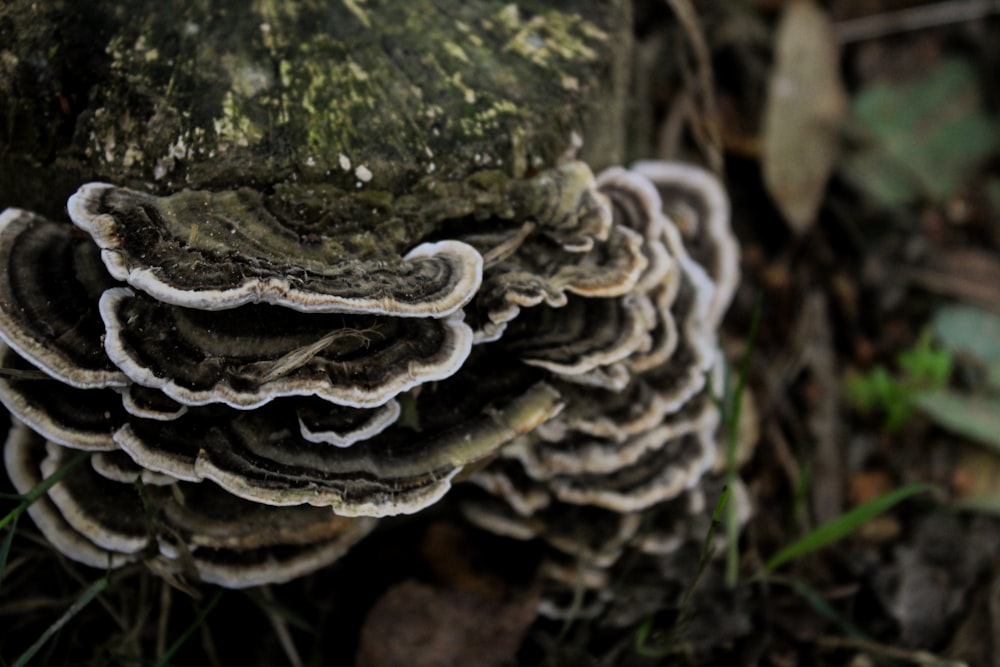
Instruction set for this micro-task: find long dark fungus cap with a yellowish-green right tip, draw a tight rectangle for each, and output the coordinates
[114,376,561,516]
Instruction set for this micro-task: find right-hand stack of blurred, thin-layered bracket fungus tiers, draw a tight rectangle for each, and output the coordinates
[463,162,748,618]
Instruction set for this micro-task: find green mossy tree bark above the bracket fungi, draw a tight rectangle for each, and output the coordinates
[0,0,631,216]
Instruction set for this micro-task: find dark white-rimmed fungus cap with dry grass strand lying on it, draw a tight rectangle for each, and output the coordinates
[100,288,472,409]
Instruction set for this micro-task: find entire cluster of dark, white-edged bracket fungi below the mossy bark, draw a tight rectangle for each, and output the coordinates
[0,155,737,600]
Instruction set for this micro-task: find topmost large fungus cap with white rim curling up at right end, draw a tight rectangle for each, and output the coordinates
[68,183,482,317]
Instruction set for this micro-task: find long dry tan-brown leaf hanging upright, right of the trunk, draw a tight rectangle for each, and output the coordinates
[761,0,847,234]
